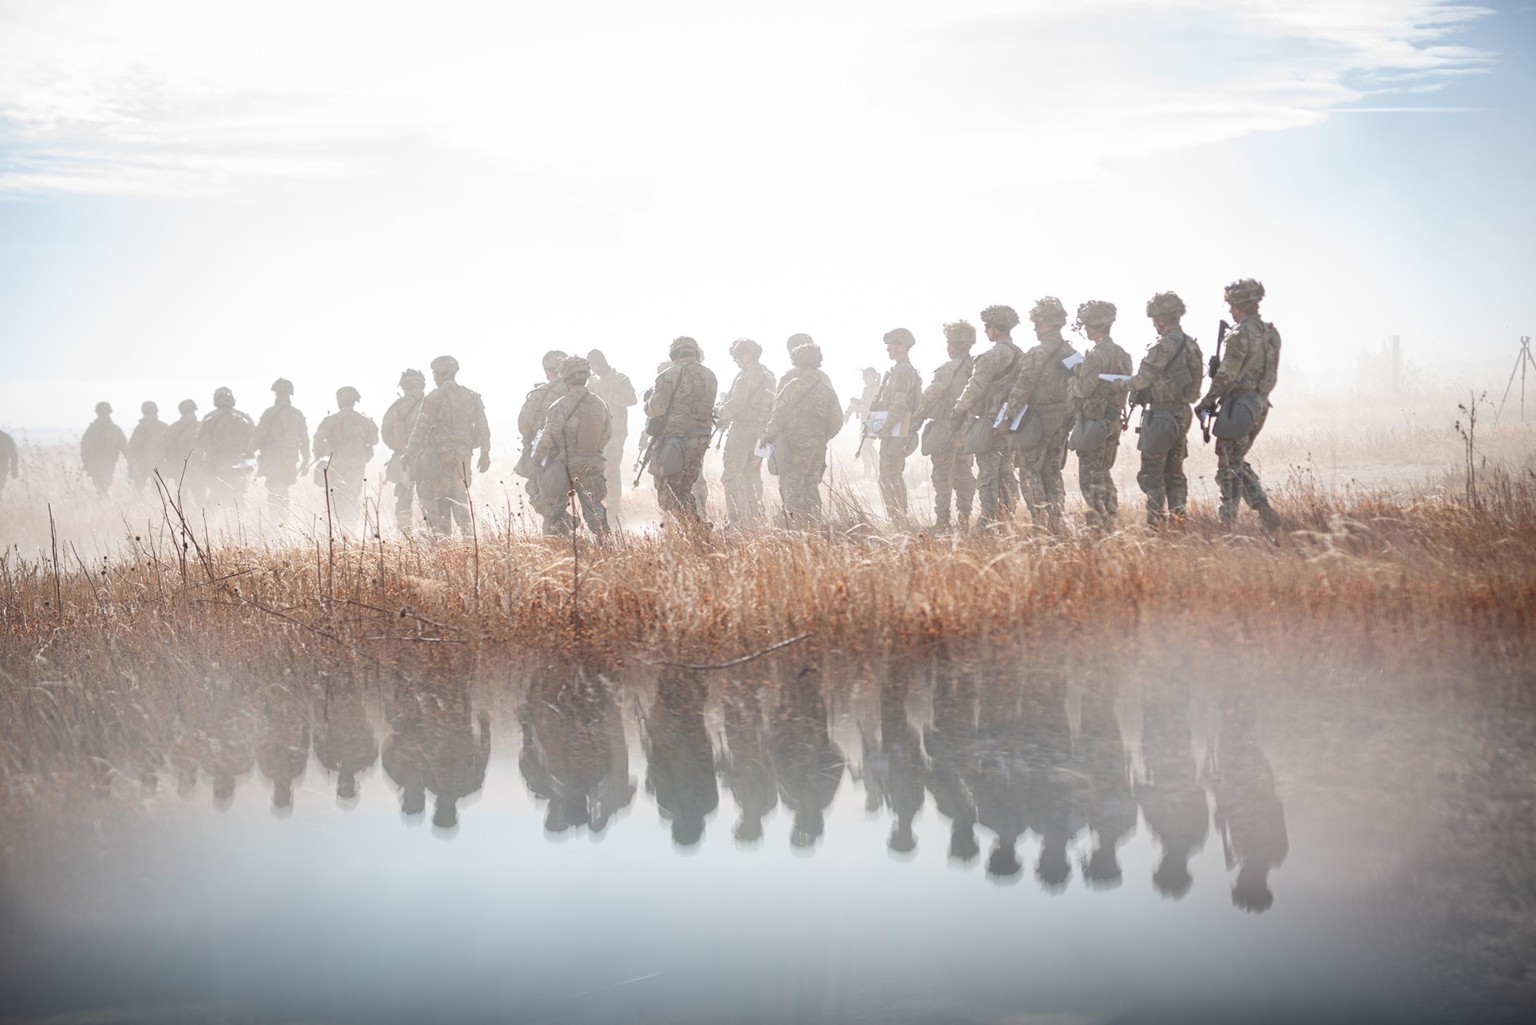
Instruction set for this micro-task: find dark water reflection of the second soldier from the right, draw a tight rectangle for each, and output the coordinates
[1135,684,1210,901]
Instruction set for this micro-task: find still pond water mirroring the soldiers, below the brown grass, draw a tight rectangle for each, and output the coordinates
[0,655,1536,1022]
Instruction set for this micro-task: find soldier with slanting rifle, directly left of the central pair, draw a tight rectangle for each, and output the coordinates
[645,335,719,519]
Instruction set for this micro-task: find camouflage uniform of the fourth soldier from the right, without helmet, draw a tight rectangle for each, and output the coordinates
[1008,318,1077,530]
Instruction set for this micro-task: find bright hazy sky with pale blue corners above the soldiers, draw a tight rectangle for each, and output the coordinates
[0,0,1536,433]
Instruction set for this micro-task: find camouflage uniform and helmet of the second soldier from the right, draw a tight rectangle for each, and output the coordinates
[1129,294,1204,527]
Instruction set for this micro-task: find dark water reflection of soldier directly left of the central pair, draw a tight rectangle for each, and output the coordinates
[641,667,720,847]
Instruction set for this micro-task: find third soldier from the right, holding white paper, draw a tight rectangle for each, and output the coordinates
[1068,300,1132,529]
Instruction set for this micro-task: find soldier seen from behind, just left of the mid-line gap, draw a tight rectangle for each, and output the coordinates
[763,341,843,527]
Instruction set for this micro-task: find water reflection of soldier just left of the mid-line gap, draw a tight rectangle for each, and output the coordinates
[773,667,848,850]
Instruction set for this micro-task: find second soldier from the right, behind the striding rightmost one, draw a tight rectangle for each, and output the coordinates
[1129,292,1206,527]
